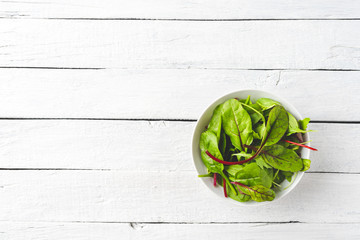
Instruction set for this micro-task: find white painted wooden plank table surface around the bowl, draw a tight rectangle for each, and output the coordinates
[0,0,360,240]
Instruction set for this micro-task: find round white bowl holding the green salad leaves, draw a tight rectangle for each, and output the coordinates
[192,90,310,206]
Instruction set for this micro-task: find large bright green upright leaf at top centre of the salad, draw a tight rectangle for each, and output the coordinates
[222,99,253,151]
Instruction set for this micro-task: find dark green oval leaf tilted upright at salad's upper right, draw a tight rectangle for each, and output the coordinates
[265,106,289,146]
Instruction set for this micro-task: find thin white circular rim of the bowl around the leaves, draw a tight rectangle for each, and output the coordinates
[191,89,310,206]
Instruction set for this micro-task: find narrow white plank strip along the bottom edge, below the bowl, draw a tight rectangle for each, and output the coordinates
[0,222,360,240]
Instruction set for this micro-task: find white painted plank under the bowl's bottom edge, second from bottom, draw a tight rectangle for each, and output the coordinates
[0,172,360,223]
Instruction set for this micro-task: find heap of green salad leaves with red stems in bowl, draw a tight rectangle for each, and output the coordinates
[199,96,316,202]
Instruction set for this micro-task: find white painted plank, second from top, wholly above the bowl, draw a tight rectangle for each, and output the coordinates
[0,19,360,70]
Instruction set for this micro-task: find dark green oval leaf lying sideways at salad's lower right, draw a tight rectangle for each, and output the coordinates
[262,144,303,172]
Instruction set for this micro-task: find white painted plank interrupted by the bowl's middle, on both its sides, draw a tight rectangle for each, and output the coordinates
[0,120,360,173]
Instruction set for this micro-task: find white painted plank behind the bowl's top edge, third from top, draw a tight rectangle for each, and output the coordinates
[0,68,360,121]
